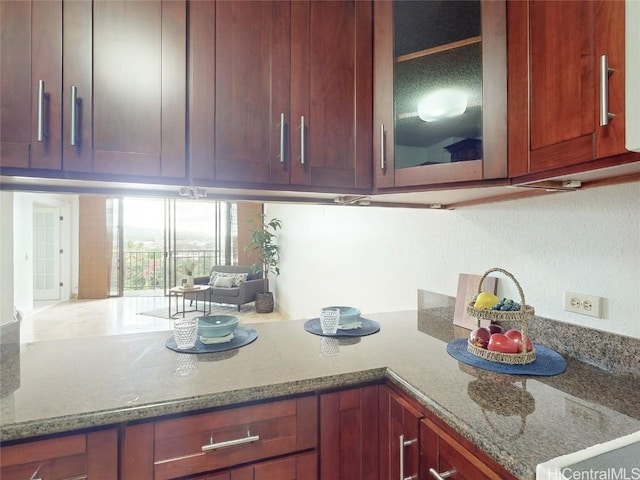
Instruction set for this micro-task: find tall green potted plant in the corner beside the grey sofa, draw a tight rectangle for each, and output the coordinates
[245,214,282,313]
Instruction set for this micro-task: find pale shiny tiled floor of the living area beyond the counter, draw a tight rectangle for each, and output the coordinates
[20,296,286,343]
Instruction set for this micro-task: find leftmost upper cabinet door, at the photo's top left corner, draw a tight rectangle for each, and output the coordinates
[0,0,62,170]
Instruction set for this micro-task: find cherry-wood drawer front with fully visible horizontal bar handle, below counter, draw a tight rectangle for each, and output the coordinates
[153,396,318,479]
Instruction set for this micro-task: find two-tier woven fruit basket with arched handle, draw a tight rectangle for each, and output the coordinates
[467,268,536,365]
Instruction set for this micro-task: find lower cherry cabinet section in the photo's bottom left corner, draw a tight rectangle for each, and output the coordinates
[0,429,118,480]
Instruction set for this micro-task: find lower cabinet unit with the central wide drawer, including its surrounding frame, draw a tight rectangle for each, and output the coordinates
[122,396,318,480]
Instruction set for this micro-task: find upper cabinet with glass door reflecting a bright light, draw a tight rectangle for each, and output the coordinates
[374,0,507,189]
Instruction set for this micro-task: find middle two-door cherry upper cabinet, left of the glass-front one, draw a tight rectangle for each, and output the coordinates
[189,1,372,188]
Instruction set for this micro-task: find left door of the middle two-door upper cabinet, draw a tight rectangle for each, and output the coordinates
[189,1,291,184]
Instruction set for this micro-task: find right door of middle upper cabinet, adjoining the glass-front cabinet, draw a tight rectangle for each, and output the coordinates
[291,1,373,189]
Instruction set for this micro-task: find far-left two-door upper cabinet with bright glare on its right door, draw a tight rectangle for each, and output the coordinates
[0,0,186,179]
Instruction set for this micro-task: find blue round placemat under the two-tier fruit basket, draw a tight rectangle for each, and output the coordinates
[447,338,567,376]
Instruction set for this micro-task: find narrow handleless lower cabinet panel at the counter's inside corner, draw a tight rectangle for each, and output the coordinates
[320,386,378,480]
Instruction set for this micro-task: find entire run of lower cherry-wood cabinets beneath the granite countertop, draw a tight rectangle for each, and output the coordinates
[0,384,515,480]
